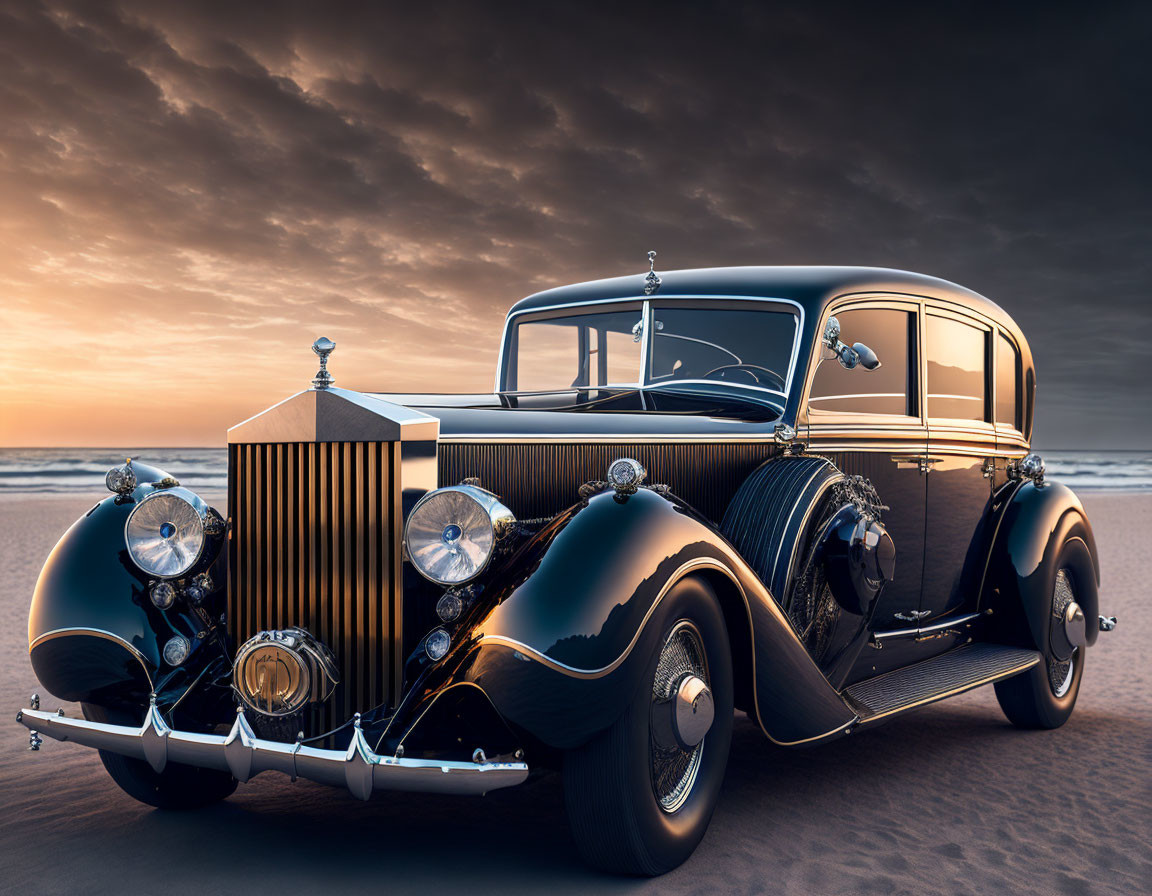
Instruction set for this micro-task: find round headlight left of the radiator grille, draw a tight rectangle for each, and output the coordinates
[124,488,207,578]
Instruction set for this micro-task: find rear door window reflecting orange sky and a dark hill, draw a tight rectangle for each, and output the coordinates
[924,314,987,420]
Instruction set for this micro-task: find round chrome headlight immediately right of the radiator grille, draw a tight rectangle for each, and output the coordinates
[404,485,516,585]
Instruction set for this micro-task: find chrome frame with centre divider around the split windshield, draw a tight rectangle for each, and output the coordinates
[494,293,804,410]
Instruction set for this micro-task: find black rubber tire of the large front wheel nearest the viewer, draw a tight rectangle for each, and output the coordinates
[563,576,733,876]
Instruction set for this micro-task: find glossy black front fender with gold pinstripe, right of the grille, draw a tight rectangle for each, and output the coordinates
[464,489,855,749]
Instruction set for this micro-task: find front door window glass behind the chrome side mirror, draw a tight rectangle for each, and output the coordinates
[808,309,916,415]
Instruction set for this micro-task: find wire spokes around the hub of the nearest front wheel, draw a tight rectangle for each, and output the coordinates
[649,621,710,812]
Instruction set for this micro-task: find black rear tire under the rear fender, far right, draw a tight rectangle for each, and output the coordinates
[995,538,1094,729]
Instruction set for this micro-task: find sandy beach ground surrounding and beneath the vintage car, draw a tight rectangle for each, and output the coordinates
[0,493,1152,895]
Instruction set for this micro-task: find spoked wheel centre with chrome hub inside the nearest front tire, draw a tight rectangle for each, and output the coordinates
[649,620,715,812]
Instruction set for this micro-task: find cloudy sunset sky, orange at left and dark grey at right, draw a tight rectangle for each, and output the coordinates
[0,0,1152,449]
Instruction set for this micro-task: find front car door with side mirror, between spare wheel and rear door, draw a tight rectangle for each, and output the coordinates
[801,297,927,684]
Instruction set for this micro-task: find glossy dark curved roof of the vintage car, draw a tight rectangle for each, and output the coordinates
[508,265,1020,335]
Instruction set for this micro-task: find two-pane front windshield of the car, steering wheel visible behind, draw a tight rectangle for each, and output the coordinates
[502,299,798,394]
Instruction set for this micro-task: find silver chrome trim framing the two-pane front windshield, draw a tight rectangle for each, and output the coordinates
[494,293,804,412]
